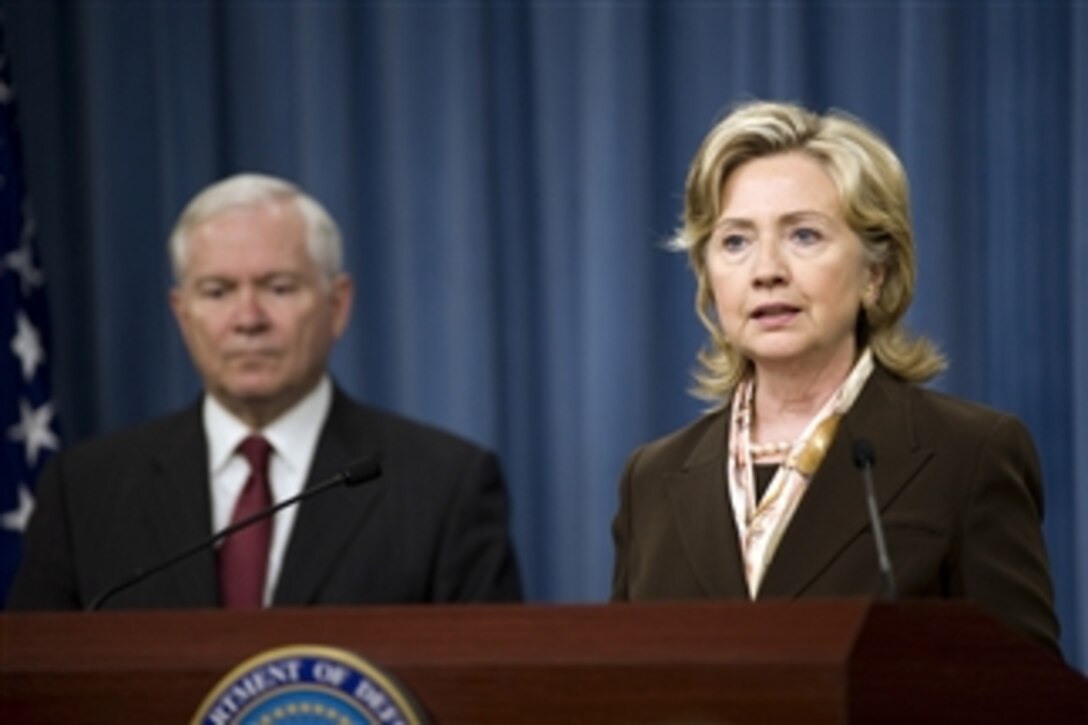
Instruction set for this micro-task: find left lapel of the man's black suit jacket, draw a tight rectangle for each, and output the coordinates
[136,404,219,606]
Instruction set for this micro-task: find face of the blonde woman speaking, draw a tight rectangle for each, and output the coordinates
[706,152,881,373]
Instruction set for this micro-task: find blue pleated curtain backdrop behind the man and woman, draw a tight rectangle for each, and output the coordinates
[7,0,1088,667]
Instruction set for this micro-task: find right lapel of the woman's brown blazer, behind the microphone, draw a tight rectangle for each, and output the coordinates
[759,368,932,599]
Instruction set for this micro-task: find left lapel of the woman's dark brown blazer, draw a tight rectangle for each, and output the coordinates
[667,409,747,598]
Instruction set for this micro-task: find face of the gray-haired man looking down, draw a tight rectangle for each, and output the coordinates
[170,202,353,428]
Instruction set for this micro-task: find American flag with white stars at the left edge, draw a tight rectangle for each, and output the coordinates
[0,11,60,603]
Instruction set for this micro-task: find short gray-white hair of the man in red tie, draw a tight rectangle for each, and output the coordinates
[170,173,344,283]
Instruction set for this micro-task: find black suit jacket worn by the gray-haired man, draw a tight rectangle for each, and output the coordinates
[9,390,521,609]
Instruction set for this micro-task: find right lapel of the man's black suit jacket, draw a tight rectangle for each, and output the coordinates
[273,389,383,605]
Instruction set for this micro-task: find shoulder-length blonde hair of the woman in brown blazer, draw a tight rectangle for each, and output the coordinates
[670,101,945,405]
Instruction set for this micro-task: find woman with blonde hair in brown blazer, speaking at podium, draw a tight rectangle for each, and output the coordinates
[613,102,1059,651]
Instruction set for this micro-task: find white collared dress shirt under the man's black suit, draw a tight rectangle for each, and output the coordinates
[203,376,333,606]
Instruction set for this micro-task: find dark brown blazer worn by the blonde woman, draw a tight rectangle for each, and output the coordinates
[613,367,1058,650]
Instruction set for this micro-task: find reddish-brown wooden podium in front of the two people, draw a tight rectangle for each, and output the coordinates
[0,600,1088,724]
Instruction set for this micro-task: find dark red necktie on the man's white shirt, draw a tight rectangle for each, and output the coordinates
[219,435,272,610]
